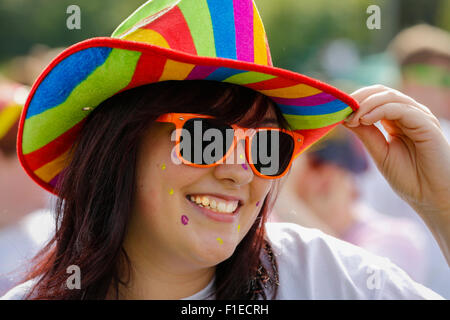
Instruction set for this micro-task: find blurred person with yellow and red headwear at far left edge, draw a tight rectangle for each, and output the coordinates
[0,79,53,295]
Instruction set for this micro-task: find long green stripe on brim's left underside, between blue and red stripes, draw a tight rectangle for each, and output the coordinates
[22,49,141,154]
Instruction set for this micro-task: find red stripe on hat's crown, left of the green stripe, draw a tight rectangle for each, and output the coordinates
[143,6,197,54]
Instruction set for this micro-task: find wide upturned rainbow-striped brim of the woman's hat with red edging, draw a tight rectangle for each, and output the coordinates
[17,38,358,194]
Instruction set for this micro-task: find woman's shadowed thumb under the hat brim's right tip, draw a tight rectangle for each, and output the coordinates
[343,122,388,171]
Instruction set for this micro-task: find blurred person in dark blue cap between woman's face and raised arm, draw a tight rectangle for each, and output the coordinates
[274,127,427,282]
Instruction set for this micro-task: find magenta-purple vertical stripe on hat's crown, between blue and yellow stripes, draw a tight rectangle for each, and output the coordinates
[233,0,255,62]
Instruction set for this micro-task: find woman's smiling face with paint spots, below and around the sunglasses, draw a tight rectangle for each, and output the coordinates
[127,110,277,267]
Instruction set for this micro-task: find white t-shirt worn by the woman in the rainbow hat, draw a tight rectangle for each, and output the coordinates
[2,223,443,300]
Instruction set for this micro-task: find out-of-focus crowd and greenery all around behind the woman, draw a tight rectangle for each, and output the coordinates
[0,0,450,298]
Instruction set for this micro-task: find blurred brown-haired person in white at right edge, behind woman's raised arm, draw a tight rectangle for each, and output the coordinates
[358,24,450,299]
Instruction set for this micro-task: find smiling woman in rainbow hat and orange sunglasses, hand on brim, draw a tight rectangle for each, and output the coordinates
[1,0,450,299]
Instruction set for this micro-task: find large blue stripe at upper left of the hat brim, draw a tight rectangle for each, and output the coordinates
[26,47,112,119]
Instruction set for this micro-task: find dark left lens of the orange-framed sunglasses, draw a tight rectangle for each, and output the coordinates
[180,118,234,165]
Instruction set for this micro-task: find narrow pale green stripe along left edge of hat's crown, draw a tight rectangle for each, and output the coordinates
[111,0,180,38]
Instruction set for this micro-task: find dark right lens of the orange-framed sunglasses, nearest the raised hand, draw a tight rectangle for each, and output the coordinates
[251,130,294,176]
